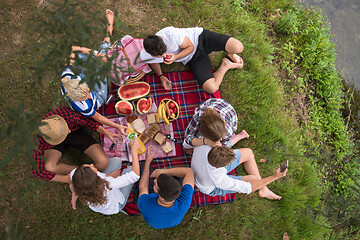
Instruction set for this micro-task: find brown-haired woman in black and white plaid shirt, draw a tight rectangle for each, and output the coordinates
[183,98,249,149]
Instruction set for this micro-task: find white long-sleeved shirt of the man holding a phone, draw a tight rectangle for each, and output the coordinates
[191,145,252,194]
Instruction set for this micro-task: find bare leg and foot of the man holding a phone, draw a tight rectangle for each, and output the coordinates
[239,148,281,200]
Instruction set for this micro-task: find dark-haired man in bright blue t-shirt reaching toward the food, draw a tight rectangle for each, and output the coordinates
[137,148,194,229]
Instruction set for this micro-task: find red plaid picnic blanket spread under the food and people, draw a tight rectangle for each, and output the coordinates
[99,71,236,206]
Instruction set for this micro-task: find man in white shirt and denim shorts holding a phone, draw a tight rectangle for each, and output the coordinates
[191,145,287,200]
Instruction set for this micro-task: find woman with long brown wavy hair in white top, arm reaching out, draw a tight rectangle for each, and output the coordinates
[70,138,140,215]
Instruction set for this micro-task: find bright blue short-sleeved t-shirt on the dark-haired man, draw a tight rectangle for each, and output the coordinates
[137,184,194,229]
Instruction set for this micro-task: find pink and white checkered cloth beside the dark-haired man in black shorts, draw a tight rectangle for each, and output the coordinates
[107,35,151,85]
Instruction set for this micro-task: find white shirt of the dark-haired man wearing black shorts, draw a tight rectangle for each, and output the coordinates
[140,27,204,65]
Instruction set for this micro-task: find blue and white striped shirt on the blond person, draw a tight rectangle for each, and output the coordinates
[61,67,100,117]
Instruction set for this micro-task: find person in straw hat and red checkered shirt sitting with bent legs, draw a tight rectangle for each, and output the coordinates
[33,107,120,183]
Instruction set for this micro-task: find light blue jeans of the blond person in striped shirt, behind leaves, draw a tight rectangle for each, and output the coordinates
[78,41,111,107]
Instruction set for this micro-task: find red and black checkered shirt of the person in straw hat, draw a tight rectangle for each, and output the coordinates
[32,107,100,181]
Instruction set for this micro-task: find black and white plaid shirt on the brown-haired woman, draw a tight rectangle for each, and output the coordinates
[183,98,238,148]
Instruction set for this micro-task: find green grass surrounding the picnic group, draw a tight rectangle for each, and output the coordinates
[0,0,358,239]
